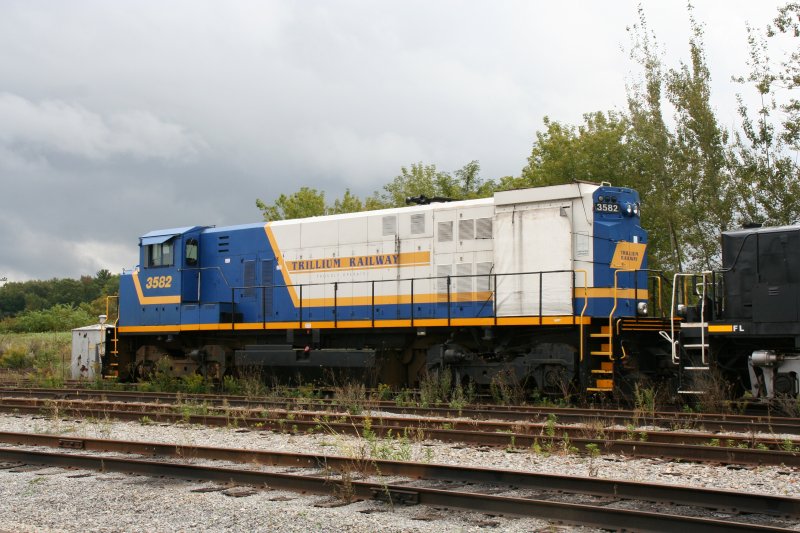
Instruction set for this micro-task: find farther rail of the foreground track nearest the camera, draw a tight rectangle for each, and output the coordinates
[0,432,800,518]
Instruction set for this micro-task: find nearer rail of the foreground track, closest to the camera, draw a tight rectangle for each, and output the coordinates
[0,448,791,533]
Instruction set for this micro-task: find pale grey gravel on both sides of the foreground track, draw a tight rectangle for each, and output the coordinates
[0,415,800,532]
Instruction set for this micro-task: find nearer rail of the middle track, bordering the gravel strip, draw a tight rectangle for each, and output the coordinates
[0,402,800,467]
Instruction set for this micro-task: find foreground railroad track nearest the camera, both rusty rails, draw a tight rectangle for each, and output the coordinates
[0,433,800,532]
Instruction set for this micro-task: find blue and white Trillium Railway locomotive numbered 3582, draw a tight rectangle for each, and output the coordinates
[109,182,663,391]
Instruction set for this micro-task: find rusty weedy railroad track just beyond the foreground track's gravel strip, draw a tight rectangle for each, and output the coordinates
[0,398,800,467]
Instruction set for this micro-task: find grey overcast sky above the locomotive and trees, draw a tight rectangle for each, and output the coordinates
[0,0,778,281]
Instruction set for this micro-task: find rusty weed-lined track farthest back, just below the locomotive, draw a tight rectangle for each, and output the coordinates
[0,387,800,439]
